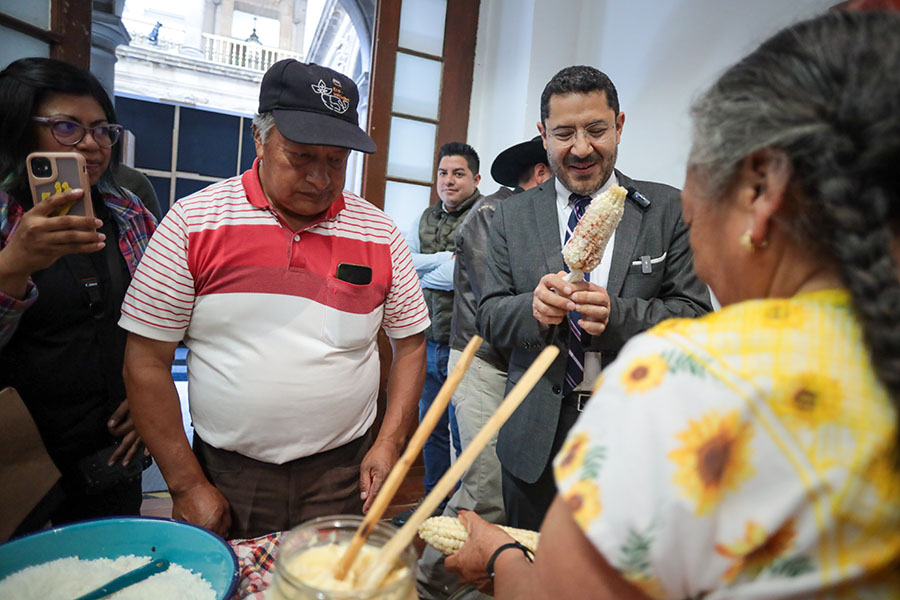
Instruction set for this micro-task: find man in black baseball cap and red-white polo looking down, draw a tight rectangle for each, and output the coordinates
[120,60,429,538]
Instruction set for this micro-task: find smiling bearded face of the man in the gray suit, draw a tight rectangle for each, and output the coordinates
[538,91,625,196]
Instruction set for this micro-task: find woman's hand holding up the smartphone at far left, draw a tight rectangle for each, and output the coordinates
[0,189,106,286]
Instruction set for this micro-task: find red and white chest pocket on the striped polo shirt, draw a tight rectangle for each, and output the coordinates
[322,277,384,350]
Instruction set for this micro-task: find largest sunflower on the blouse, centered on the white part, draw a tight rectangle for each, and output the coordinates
[669,411,754,515]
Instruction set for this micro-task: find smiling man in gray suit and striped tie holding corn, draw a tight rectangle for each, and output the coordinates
[477,66,712,529]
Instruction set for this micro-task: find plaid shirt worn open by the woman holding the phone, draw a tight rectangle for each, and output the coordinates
[0,190,156,347]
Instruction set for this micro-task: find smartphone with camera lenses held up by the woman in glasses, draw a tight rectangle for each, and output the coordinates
[25,152,94,217]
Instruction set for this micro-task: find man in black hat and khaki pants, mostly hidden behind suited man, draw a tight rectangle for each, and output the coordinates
[418,136,551,599]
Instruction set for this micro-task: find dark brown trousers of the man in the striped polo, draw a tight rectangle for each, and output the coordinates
[194,429,375,538]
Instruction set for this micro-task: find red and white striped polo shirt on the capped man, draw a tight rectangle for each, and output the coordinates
[119,163,429,464]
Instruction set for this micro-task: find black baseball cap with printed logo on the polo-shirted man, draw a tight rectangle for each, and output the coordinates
[259,58,375,154]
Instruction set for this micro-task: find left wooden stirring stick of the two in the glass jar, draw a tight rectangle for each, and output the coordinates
[334,335,483,581]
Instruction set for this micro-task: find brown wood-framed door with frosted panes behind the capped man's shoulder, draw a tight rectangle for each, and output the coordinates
[363,0,479,237]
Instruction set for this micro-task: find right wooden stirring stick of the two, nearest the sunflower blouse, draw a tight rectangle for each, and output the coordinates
[361,346,559,589]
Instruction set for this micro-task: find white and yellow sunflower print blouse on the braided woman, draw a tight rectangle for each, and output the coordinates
[554,290,900,600]
